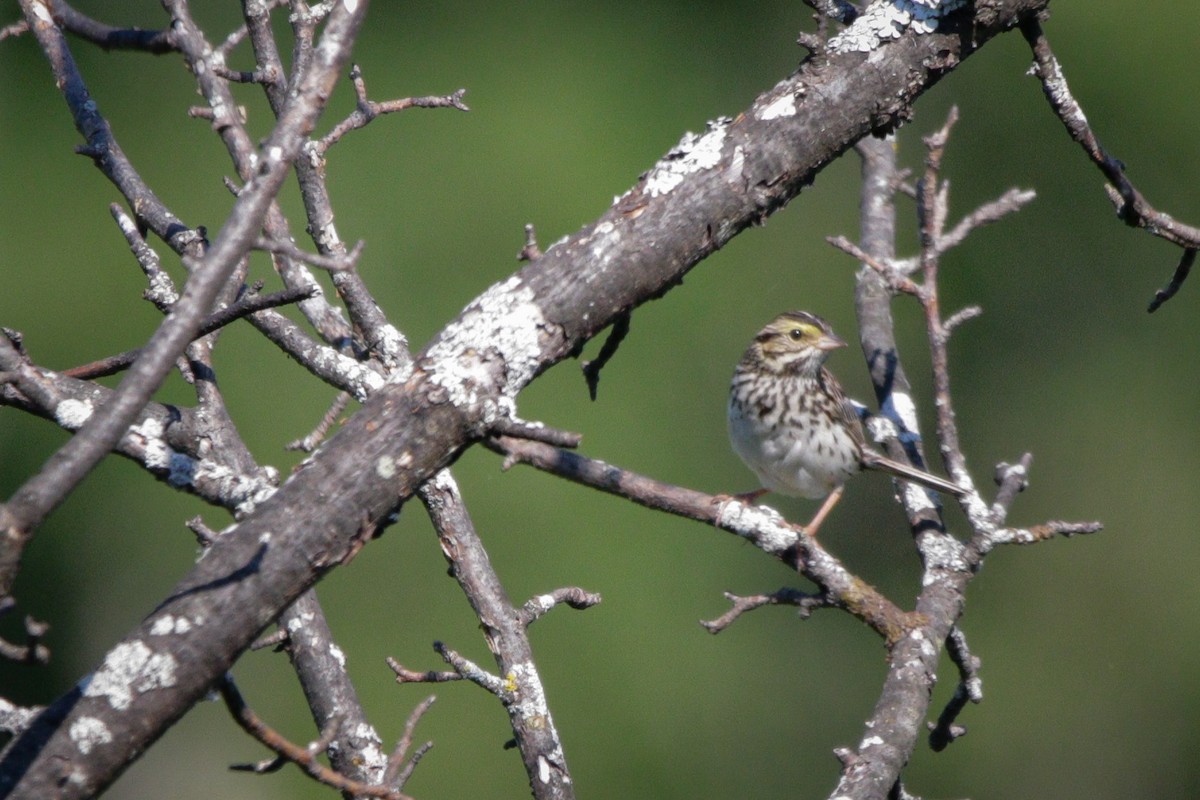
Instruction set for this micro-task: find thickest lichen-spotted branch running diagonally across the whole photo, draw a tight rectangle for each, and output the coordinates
[0,0,1046,798]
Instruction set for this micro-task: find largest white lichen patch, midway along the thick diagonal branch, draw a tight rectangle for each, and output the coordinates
[427,275,546,412]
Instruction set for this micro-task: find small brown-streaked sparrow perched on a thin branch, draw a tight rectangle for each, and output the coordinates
[728,311,966,535]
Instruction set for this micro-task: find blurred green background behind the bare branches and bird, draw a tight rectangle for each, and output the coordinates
[0,0,1200,800]
